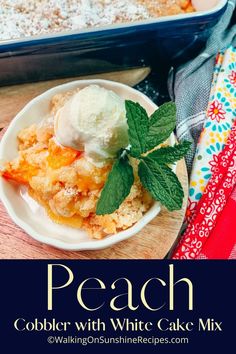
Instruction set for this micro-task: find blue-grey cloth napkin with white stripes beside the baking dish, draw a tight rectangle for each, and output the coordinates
[168,0,236,173]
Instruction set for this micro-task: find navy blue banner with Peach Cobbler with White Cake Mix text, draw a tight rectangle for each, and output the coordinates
[0,260,236,354]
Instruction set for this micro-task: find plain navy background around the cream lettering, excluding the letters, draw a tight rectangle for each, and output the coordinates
[0,260,236,354]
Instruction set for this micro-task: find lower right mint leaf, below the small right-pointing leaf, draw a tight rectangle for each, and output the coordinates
[138,157,184,211]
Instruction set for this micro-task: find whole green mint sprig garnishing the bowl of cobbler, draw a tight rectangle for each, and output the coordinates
[96,101,191,215]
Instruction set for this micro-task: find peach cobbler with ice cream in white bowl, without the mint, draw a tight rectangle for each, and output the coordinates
[2,86,152,239]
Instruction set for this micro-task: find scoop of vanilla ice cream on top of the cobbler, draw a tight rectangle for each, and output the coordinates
[54,85,128,165]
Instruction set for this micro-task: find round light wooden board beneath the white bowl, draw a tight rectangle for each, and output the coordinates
[0,68,188,259]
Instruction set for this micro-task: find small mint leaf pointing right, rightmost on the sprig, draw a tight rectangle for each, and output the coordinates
[148,141,191,165]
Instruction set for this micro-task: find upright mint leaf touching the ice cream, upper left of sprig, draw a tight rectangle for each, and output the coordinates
[125,100,149,157]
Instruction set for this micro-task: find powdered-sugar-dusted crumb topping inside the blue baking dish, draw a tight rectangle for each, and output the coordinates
[0,0,194,40]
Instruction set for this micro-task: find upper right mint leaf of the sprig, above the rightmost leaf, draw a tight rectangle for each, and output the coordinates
[146,102,176,151]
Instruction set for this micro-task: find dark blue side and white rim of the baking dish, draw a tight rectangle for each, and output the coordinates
[0,0,227,86]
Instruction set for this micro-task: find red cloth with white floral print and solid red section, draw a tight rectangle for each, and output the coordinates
[172,121,236,259]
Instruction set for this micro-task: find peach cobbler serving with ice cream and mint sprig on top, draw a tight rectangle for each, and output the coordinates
[0,85,190,239]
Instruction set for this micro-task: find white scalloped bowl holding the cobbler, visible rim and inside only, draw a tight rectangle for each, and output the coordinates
[0,80,175,251]
